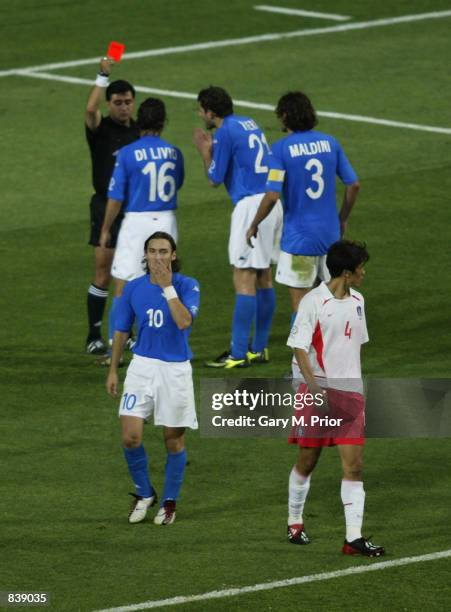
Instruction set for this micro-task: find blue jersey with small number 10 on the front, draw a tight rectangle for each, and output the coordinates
[115,273,200,361]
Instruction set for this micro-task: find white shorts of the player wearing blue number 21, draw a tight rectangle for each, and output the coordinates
[229,193,283,270]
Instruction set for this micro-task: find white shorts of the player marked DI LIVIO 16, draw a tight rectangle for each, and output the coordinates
[111,210,177,281]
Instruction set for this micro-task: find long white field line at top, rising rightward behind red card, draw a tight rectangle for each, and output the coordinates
[0,10,451,77]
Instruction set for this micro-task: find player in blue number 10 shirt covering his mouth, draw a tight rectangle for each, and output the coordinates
[106,232,200,525]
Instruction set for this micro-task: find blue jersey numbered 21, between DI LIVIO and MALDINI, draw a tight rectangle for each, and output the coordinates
[208,115,271,205]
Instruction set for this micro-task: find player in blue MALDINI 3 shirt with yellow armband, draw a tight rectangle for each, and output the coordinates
[246,91,360,320]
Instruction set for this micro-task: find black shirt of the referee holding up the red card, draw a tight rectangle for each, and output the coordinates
[85,117,139,199]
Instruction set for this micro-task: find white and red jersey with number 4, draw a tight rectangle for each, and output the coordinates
[287,283,369,390]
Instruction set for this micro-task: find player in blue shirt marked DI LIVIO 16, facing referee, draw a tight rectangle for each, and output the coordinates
[100,98,184,361]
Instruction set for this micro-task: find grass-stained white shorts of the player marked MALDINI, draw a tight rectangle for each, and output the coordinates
[276,251,330,289]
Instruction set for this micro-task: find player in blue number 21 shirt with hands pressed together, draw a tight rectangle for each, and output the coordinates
[194,86,282,369]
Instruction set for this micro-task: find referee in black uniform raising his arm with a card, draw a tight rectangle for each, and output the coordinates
[85,57,139,355]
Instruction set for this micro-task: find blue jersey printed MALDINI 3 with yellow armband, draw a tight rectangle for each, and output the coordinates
[266,130,357,255]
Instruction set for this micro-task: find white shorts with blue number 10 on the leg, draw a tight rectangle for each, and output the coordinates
[119,355,199,429]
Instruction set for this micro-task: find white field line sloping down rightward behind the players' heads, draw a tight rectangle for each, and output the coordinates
[18,70,451,135]
